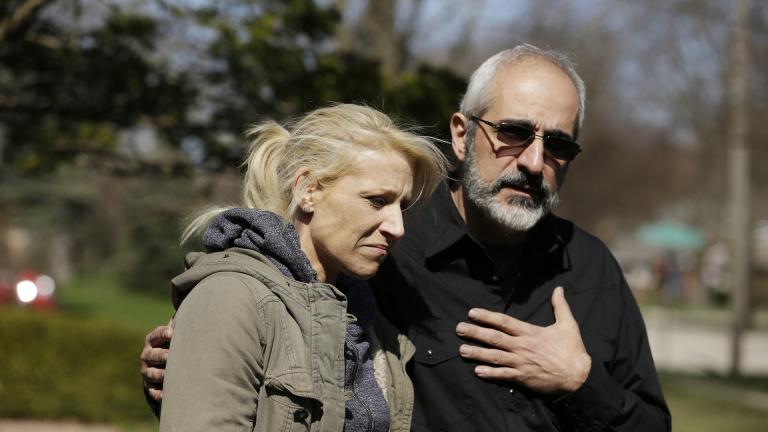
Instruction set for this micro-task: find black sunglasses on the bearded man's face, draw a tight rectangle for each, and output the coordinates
[470,116,581,161]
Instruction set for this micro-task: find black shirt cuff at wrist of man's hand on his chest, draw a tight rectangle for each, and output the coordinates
[554,358,624,431]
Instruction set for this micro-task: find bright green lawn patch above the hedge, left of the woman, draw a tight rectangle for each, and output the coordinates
[57,275,173,330]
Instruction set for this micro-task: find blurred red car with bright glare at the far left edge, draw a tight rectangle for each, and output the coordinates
[0,270,56,310]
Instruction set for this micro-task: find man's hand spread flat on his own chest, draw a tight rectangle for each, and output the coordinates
[456,287,592,393]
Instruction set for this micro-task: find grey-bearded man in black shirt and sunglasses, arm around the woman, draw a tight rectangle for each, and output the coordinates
[142,45,670,432]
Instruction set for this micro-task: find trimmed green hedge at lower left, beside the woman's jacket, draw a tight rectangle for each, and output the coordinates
[0,308,152,423]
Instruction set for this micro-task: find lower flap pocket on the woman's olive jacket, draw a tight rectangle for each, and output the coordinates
[252,386,320,432]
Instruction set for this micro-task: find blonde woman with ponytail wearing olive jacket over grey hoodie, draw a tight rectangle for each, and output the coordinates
[160,105,446,432]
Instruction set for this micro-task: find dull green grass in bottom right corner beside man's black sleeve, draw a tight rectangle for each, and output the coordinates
[661,374,768,432]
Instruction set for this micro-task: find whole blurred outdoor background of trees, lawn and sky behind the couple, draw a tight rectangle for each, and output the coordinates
[0,0,768,432]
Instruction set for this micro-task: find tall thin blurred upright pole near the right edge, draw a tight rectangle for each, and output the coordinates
[727,0,752,376]
